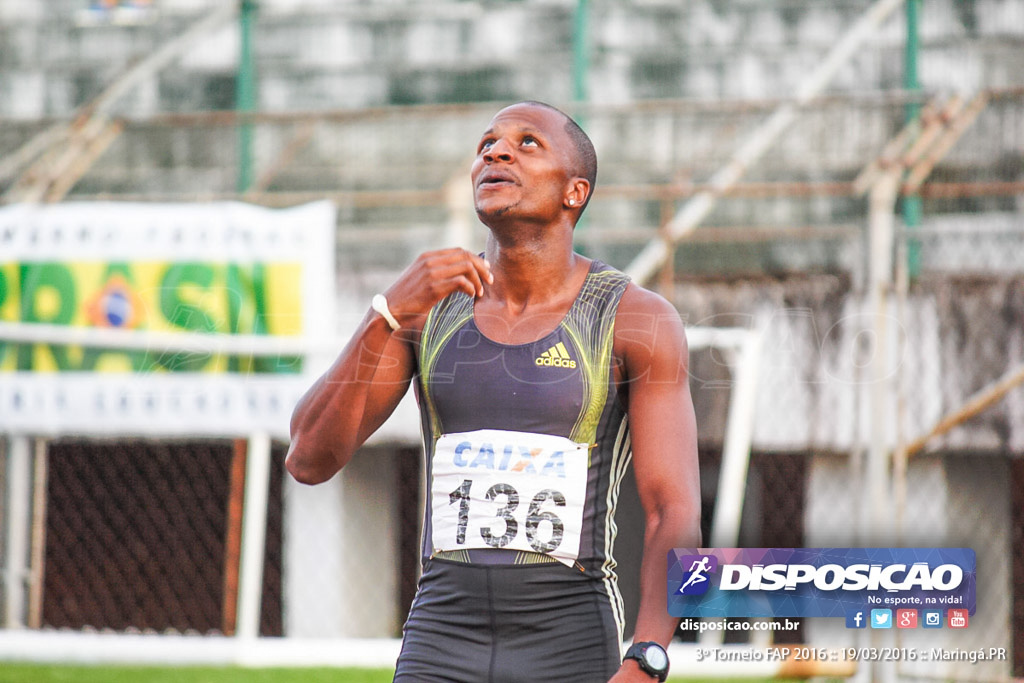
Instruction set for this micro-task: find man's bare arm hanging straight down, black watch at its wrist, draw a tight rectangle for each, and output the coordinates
[612,285,700,683]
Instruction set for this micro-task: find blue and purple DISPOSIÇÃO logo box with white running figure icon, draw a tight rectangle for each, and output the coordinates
[668,548,976,616]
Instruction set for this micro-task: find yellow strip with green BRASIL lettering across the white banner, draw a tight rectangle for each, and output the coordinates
[0,261,302,374]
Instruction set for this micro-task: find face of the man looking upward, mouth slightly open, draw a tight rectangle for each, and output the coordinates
[471,104,573,224]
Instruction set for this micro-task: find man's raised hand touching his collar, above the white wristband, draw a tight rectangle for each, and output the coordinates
[384,248,495,328]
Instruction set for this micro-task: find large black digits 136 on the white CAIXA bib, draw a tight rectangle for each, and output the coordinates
[442,479,565,553]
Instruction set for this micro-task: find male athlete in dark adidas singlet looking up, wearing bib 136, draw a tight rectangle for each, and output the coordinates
[287,102,700,683]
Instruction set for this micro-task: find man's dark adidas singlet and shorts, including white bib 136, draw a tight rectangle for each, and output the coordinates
[395,261,631,682]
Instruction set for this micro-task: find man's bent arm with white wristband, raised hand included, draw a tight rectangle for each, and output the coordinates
[285,249,493,484]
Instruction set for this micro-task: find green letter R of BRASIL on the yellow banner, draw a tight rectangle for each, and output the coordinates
[17,263,78,371]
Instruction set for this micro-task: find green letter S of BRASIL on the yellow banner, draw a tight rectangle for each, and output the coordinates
[157,263,217,372]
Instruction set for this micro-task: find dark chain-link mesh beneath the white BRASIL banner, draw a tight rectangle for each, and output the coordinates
[34,438,284,636]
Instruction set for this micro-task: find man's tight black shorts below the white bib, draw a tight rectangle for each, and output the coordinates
[394,559,622,683]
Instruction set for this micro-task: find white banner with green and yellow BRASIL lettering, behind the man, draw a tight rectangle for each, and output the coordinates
[0,202,335,435]
